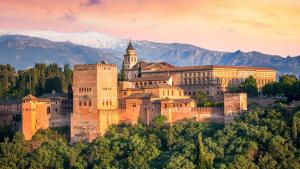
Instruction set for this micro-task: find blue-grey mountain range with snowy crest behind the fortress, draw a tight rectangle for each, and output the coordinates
[0,31,300,75]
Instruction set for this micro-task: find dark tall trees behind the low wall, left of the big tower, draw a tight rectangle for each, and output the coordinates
[0,64,72,99]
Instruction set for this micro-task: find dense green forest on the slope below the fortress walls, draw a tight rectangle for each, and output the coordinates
[0,104,300,169]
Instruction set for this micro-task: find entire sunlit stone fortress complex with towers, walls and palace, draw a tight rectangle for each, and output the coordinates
[0,42,276,142]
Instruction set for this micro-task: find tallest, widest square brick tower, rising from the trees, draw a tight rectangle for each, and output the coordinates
[71,63,118,142]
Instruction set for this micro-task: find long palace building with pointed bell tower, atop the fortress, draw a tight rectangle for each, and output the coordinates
[124,42,276,99]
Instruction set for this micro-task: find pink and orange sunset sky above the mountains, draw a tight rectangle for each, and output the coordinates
[0,0,300,57]
